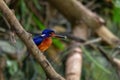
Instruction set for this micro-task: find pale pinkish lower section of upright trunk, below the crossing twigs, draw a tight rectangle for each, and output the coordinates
[66,47,82,80]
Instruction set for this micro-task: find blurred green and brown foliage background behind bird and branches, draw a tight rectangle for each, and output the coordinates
[0,0,120,80]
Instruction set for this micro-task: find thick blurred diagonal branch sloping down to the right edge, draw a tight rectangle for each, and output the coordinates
[48,0,120,46]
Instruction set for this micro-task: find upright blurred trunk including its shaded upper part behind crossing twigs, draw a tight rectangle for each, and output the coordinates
[66,23,88,80]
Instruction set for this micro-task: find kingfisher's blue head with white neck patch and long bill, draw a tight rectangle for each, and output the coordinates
[41,29,66,38]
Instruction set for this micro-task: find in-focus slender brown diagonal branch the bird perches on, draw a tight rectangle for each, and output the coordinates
[0,0,65,80]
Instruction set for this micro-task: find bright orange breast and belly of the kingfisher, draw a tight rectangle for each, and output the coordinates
[38,38,52,52]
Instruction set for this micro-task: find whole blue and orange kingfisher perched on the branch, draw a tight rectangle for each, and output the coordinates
[33,29,66,52]
